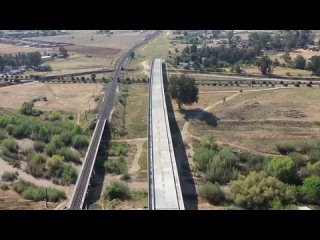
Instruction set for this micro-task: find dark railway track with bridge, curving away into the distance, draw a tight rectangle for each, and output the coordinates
[68,31,159,210]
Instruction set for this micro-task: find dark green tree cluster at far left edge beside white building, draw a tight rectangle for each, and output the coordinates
[0,51,41,71]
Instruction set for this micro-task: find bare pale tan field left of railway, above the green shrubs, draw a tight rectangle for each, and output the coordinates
[0,82,103,112]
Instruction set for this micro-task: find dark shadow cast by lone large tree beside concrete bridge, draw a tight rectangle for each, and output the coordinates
[180,108,219,127]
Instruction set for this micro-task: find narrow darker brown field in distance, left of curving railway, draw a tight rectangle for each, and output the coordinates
[56,45,121,57]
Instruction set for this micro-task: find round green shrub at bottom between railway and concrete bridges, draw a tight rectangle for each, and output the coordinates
[105,181,130,200]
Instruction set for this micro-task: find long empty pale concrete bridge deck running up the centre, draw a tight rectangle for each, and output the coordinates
[148,59,184,210]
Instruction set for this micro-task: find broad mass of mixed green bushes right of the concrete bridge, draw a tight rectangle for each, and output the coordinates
[193,137,320,209]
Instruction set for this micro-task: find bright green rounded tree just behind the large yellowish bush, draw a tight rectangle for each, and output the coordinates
[266,157,297,183]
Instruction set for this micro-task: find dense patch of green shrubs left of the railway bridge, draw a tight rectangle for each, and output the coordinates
[0,102,94,185]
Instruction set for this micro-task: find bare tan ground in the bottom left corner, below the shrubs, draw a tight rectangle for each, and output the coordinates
[0,189,59,210]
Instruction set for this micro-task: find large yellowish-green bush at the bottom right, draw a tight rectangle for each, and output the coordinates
[230,172,291,209]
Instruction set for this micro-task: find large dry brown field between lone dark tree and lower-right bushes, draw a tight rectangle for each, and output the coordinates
[188,89,320,154]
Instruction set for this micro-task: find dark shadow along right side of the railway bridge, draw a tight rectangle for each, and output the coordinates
[84,124,111,209]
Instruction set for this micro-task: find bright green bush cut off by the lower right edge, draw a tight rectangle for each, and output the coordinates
[301,176,320,204]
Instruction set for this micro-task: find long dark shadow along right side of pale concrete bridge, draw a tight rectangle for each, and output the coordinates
[162,64,198,210]
